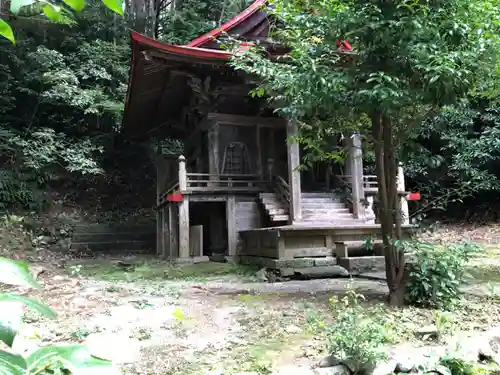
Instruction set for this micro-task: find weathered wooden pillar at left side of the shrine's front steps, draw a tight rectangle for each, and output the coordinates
[286,121,302,224]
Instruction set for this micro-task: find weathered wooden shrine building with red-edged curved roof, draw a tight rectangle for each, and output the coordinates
[124,0,408,269]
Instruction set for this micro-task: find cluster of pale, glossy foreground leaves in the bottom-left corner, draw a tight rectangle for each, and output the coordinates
[0,258,112,375]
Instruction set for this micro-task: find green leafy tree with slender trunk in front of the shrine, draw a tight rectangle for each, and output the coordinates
[234,0,498,305]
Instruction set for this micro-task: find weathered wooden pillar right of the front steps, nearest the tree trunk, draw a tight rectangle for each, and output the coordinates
[348,133,365,219]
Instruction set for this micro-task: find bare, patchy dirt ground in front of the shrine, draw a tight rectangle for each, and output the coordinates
[6,228,500,375]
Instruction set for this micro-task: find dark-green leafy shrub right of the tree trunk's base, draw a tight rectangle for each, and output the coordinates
[406,242,481,310]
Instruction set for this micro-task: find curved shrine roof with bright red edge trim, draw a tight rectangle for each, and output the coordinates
[123,0,352,136]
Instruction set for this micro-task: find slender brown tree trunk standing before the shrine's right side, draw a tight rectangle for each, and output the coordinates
[371,113,407,306]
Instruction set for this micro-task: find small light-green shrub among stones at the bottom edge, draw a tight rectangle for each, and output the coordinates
[327,285,386,374]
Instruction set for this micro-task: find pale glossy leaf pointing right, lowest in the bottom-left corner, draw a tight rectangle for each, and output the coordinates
[26,345,112,371]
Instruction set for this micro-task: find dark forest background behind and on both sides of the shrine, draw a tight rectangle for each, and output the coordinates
[0,0,500,226]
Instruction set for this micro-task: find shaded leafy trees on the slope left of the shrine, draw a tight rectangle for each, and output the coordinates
[0,4,129,208]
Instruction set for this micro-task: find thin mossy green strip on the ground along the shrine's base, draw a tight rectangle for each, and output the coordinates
[73,261,258,281]
